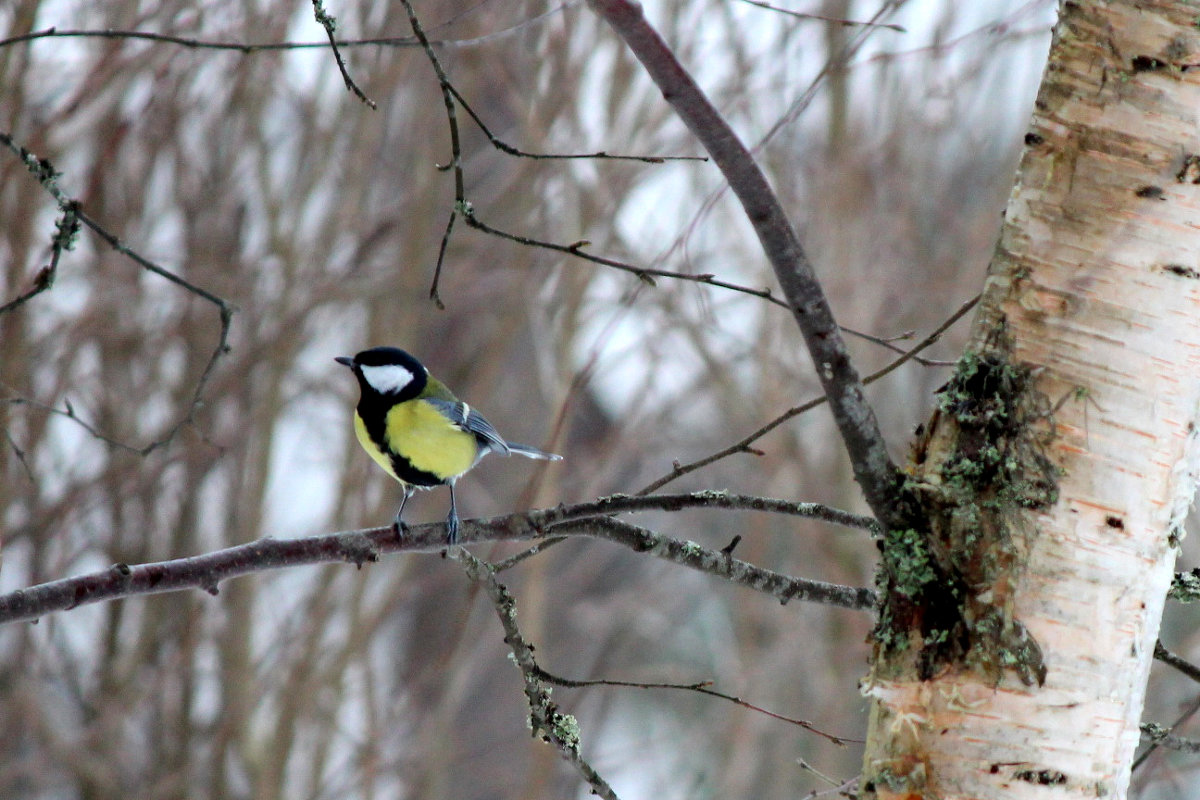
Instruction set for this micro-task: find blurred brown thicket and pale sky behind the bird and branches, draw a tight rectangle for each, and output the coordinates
[7,0,1190,800]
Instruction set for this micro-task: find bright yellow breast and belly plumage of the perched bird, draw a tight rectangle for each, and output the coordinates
[354,399,479,482]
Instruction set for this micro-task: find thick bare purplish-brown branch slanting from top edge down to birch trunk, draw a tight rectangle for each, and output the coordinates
[589,0,904,527]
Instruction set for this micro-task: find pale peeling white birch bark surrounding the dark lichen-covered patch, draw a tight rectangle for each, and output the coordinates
[863,0,1200,799]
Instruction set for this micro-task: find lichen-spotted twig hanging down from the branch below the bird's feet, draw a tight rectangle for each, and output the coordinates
[450,547,618,800]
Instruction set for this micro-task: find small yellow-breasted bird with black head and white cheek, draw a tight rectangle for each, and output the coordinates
[335,347,563,545]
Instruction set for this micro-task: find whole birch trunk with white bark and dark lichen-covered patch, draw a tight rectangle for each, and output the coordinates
[863,0,1200,799]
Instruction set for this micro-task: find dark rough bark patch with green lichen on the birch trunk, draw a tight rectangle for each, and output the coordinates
[874,336,1058,684]
